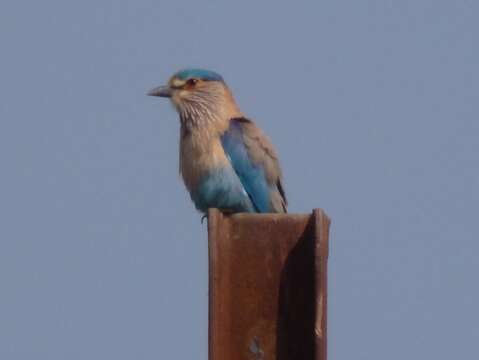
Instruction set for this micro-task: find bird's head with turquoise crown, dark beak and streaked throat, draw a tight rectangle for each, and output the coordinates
[148,69,239,119]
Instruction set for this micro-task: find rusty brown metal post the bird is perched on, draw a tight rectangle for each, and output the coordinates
[208,209,330,360]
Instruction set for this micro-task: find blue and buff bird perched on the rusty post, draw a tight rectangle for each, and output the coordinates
[147,68,287,216]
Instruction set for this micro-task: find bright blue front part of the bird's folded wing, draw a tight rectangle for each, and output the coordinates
[221,121,271,213]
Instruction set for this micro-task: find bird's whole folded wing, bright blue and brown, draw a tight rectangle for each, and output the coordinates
[221,118,287,213]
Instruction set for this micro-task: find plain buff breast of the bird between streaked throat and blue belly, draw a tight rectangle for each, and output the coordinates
[180,130,231,191]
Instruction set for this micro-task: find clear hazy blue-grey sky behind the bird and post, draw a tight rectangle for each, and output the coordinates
[0,0,479,360]
